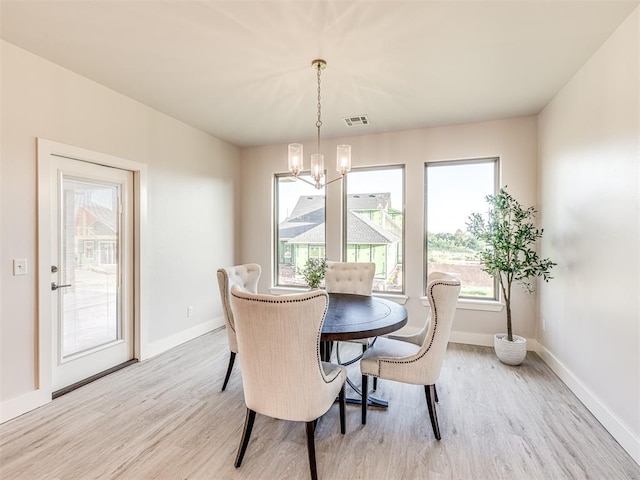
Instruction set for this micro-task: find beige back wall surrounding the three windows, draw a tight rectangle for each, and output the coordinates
[240,117,537,345]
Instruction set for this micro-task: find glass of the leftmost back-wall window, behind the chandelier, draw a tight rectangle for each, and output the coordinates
[274,175,326,286]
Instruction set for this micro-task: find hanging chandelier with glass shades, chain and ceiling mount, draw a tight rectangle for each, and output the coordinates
[289,59,351,189]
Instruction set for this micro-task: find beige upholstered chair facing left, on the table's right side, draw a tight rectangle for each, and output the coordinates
[360,274,460,440]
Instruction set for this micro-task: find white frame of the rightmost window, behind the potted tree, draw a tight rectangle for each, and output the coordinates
[422,155,502,305]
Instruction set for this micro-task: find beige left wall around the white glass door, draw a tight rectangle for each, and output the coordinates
[0,41,239,415]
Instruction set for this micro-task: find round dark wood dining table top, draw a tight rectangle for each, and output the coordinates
[321,293,407,342]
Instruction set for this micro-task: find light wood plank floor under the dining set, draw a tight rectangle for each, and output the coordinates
[0,330,640,480]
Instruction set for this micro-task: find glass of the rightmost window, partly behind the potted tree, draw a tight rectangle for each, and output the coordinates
[425,158,498,300]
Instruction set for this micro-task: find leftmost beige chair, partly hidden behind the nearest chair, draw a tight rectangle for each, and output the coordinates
[218,263,261,391]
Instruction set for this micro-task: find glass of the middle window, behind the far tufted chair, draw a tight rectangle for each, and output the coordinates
[343,166,404,293]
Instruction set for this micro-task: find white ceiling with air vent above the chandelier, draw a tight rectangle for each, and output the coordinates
[0,0,640,147]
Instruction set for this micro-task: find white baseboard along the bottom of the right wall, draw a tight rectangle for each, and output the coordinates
[537,345,640,465]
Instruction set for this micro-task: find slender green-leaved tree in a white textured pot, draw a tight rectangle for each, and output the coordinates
[467,188,556,365]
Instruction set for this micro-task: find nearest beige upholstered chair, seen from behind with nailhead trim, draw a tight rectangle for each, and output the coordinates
[231,286,347,479]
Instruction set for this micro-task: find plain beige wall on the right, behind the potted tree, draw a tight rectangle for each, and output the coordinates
[539,9,640,463]
